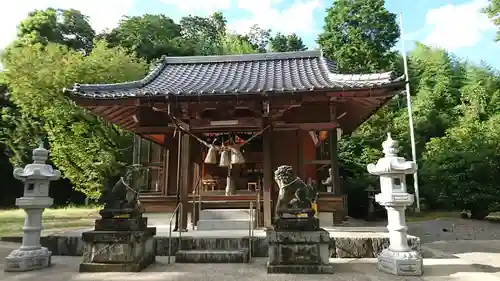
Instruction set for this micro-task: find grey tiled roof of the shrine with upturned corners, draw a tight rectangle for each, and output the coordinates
[65,51,400,99]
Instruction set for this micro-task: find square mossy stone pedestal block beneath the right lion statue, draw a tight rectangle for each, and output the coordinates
[266,225,333,274]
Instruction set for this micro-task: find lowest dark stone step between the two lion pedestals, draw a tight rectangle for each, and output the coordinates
[175,248,250,263]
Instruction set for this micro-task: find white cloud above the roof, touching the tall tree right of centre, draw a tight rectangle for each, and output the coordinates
[228,0,322,34]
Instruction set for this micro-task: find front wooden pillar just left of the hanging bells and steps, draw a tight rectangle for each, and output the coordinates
[179,133,191,231]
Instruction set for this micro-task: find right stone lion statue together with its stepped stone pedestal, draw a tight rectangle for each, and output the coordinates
[266,166,333,274]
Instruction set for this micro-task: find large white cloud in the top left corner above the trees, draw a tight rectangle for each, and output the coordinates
[0,0,134,50]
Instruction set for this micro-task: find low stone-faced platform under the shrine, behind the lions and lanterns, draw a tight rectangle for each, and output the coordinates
[3,225,420,258]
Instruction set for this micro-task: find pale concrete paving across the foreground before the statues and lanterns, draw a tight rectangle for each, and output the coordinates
[0,256,500,281]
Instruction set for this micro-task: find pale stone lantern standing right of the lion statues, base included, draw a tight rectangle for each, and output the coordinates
[367,134,423,276]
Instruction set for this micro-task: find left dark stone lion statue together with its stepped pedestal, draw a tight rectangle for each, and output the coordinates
[79,165,156,272]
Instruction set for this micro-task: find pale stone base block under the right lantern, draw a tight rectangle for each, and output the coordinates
[377,249,424,276]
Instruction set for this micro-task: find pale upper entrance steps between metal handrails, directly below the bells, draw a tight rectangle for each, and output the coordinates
[196,209,255,230]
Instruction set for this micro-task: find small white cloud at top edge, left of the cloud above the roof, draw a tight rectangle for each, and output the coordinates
[161,0,231,16]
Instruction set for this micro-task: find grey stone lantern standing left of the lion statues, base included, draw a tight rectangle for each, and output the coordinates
[5,145,61,271]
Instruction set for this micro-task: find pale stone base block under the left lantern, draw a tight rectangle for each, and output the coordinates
[4,247,52,272]
